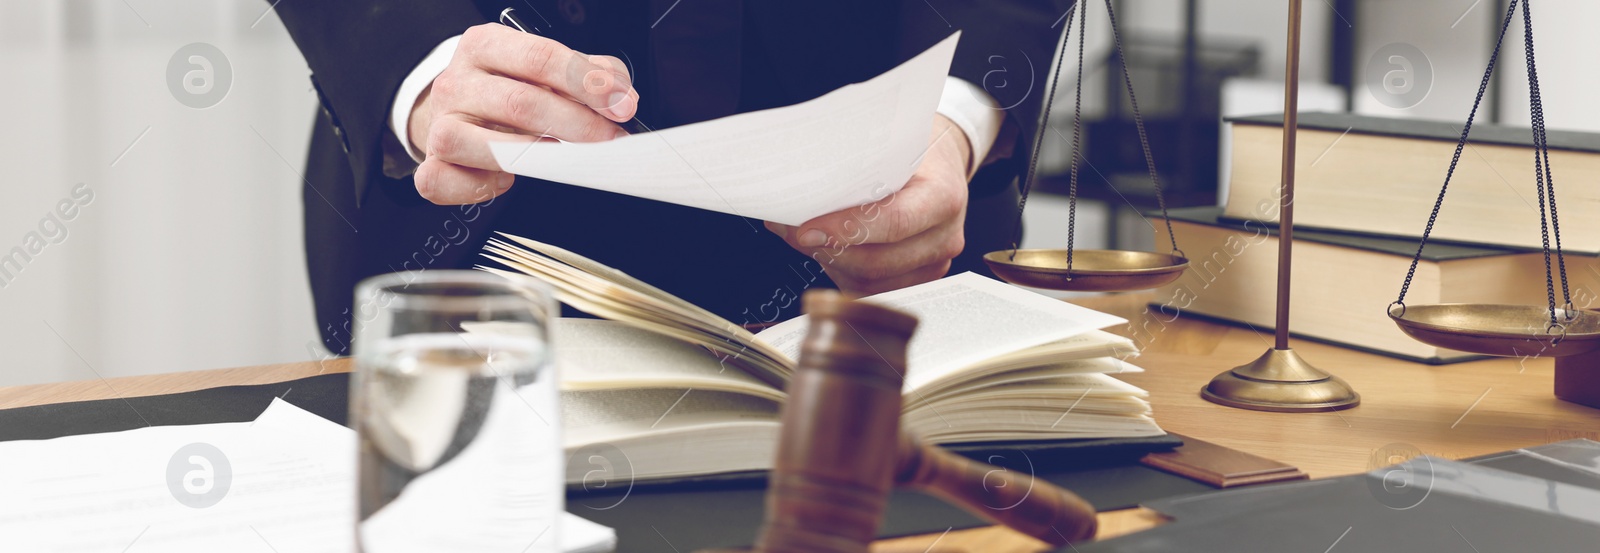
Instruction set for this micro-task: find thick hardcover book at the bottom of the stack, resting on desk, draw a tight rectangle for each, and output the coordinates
[1155,208,1600,364]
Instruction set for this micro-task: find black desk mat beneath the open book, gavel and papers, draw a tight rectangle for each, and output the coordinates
[0,374,1213,553]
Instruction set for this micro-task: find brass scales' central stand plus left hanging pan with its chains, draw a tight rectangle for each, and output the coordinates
[984,0,1360,412]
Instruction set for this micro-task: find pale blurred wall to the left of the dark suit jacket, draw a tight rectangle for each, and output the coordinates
[0,0,315,385]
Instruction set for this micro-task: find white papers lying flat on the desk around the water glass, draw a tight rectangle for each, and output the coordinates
[0,400,616,553]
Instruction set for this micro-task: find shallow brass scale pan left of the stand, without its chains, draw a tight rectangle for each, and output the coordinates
[984,249,1189,292]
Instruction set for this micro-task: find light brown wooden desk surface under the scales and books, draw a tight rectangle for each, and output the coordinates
[0,294,1600,551]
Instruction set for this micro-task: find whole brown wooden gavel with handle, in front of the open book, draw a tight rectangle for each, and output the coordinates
[755,291,1096,553]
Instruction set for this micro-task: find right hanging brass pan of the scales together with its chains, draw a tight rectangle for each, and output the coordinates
[1387,0,1600,358]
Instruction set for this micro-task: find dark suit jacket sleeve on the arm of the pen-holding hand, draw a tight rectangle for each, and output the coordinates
[274,0,486,200]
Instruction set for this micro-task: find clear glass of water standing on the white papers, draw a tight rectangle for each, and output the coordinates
[350,270,565,553]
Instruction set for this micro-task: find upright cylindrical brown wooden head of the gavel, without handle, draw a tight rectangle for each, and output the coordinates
[757,291,917,553]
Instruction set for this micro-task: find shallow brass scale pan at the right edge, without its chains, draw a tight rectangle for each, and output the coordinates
[1389,304,1600,356]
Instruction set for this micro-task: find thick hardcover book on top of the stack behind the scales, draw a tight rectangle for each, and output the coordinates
[1222,113,1600,253]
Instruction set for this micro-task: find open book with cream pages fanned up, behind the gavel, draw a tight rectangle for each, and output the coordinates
[478,235,1163,481]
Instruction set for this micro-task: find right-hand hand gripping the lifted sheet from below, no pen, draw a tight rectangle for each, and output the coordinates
[766,115,971,296]
